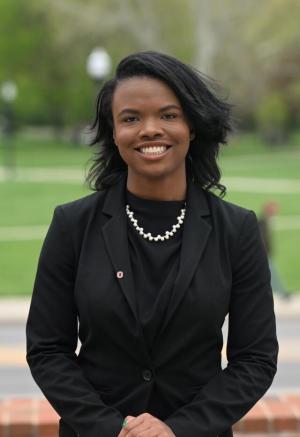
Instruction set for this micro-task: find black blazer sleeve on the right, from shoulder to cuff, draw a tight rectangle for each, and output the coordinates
[166,211,278,437]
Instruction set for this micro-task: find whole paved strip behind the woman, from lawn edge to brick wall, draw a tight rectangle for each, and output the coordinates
[0,294,300,398]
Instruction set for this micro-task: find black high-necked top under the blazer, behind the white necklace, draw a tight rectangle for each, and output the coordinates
[127,190,185,349]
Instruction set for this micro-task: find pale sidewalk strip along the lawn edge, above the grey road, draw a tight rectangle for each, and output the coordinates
[0,293,300,324]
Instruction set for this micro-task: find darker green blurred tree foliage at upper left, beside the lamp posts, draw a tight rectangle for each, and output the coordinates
[0,0,92,128]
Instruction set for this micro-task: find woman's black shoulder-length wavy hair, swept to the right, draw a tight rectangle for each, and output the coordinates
[87,51,231,196]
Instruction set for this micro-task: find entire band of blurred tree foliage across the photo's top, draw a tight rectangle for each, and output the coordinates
[0,0,300,130]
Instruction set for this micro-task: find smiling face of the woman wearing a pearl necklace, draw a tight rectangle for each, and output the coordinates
[112,76,192,183]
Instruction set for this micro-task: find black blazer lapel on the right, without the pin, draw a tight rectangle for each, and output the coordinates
[161,181,211,332]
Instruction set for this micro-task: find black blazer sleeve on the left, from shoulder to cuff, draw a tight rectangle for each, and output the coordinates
[26,207,123,437]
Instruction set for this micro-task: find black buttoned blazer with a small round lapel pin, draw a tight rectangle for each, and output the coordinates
[27,176,278,437]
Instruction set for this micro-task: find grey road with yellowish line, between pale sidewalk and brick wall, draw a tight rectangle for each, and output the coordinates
[0,314,300,399]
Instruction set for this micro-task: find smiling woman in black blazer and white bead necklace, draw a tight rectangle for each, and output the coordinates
[27,52,277,437]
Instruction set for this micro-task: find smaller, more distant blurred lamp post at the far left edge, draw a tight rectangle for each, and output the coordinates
[0,81,18,175]
